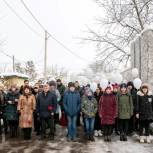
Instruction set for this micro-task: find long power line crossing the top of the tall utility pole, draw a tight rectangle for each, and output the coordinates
[20,0,89,62]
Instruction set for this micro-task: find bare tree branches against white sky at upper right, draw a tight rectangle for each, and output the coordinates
[83,0,153,66]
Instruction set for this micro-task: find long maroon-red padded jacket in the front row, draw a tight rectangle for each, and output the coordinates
[99,94,117,125]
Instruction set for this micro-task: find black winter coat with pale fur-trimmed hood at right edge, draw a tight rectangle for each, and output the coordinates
[136,91,153,120]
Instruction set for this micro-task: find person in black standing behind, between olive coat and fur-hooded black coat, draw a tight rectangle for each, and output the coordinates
[127,81,139,134]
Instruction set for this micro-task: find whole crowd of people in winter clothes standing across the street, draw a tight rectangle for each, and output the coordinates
[0,79,153,143]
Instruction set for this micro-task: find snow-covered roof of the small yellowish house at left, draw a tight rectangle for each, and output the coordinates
[0,72,29,79]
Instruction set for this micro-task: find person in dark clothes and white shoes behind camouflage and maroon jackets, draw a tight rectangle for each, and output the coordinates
[94,87,102,137]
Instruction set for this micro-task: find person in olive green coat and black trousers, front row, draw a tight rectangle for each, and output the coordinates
[118,83,133,141]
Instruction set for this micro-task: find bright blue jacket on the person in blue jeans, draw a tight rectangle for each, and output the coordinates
[63,91,81,116]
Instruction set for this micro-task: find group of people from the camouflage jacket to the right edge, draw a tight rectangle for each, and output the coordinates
[81,82,153,143]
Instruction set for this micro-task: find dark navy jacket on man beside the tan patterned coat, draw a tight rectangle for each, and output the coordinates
[36,91,57,118]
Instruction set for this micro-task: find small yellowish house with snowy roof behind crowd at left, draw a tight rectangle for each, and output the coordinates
[0,72,29,89]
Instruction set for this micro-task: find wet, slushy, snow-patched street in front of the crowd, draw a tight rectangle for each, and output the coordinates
[0,127,153,153]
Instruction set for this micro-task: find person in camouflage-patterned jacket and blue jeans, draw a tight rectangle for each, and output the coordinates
[81,90,98,141]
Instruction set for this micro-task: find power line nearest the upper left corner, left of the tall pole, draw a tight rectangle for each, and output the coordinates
[3,0,43,38]
